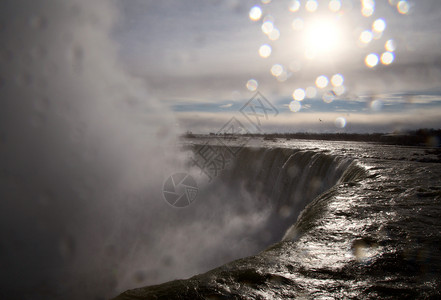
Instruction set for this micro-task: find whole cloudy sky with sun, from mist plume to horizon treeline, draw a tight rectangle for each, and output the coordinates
[113,0,441,132]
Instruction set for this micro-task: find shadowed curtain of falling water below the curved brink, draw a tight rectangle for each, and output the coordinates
[193,147,364,250]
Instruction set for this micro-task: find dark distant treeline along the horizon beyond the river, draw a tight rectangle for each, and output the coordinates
[184,128,441,147]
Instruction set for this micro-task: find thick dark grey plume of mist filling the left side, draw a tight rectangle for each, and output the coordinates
[0,1,180,299]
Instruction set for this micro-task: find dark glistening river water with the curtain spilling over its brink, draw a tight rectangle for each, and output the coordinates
[116,139,441,299]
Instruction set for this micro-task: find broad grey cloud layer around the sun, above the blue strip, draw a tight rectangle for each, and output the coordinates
[117,1,441,106]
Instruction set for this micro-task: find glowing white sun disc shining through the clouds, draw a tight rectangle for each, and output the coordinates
[303,18,343,58]
